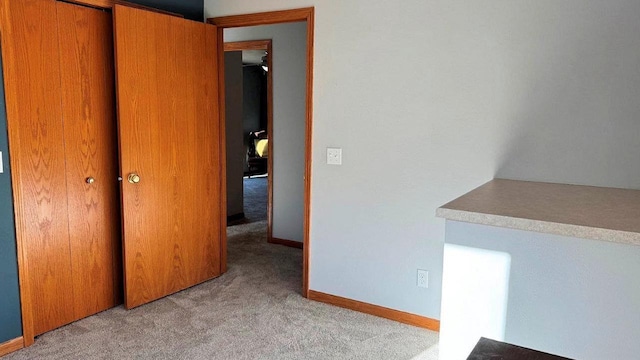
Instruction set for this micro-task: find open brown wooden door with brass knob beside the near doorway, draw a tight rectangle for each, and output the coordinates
[113,5,222,308]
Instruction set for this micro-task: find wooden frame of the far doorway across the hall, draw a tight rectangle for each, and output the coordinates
[224,39,273,243]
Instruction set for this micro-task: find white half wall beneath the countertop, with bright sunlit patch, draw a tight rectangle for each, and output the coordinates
[440,221,640,360]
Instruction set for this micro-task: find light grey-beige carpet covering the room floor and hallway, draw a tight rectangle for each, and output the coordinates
[2,221,438,360]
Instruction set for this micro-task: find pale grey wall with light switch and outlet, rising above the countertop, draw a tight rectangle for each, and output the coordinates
[205,0,640,318]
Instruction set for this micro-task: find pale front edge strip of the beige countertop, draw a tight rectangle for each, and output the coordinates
[436,207,640,246]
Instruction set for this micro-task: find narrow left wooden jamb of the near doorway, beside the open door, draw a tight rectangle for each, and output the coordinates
[214,25,227,275]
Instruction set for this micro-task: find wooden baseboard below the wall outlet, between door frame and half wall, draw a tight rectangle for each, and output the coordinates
[309,290,440,331]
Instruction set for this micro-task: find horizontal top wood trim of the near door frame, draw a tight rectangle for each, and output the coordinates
[207,7,313,29]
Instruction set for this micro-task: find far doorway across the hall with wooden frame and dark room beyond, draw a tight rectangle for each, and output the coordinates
[224,40,273,236]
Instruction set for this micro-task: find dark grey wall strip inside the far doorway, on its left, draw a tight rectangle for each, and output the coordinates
[224,51,245,216]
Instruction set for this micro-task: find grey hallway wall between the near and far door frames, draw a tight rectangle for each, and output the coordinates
[224,23,307,241]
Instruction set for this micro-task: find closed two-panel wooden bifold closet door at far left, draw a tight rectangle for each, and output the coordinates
[0,0,122,338]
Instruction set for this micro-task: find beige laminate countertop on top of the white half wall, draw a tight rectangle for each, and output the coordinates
[436,179,640,245]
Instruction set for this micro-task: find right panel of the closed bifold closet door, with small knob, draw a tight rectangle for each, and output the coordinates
[57,2,122,319]
